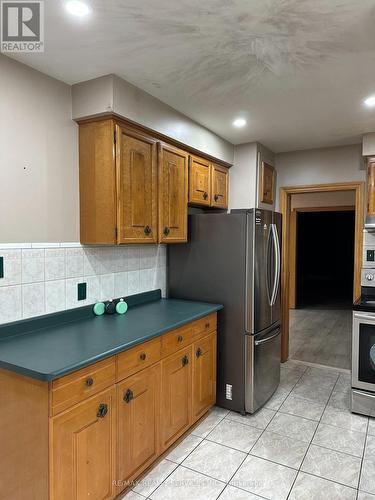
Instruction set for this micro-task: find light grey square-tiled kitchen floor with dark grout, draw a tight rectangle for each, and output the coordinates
[122,361,375,500]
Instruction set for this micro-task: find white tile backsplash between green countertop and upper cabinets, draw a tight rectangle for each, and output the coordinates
[0,243,166,324]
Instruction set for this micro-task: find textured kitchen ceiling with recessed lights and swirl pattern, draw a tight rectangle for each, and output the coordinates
[8,0,375,152]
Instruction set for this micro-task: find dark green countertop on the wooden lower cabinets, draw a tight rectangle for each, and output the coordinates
[0,292,222,381]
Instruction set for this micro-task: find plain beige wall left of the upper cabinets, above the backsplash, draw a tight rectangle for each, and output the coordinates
[0,55,79,243]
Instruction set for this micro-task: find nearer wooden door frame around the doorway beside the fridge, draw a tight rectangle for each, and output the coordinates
[280,181,365,363]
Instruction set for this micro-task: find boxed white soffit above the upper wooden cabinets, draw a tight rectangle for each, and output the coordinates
[72,75,234,163]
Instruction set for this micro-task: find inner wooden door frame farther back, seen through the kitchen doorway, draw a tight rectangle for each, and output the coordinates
[289,205,355,309]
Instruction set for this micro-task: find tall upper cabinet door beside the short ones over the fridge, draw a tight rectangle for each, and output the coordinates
[159,144,188,243]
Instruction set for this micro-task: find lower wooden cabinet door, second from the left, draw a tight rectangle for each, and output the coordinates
[117,363,160,487]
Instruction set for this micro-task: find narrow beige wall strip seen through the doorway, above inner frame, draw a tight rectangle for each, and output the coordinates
[291,191,355,210]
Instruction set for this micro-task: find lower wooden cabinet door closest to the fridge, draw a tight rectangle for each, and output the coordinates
[193,333,216,421]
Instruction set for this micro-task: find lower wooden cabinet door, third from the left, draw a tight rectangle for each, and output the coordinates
[161,346,192,451]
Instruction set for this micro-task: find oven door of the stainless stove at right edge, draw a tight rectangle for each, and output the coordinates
[352,311,375,392]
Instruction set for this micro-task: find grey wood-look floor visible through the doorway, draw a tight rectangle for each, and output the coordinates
[289,309,352,370]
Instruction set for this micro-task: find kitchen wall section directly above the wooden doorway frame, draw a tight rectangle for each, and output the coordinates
[275,144,366,207]
